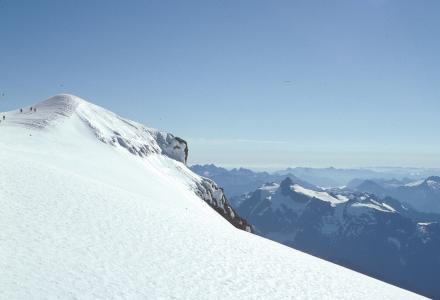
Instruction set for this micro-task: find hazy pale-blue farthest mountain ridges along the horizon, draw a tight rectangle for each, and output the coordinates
[190,164,440,213]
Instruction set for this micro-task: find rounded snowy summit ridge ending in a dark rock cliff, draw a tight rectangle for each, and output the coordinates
[3,94,188,163]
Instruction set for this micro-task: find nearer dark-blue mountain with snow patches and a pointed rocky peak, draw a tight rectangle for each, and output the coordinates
[232,178,440,298]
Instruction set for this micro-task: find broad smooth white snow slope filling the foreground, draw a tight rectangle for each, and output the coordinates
[0,96,419,299]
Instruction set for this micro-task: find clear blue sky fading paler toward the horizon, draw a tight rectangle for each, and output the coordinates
[0,0,440,168]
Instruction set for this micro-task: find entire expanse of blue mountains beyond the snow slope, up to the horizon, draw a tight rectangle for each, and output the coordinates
[191,165,440,298]
